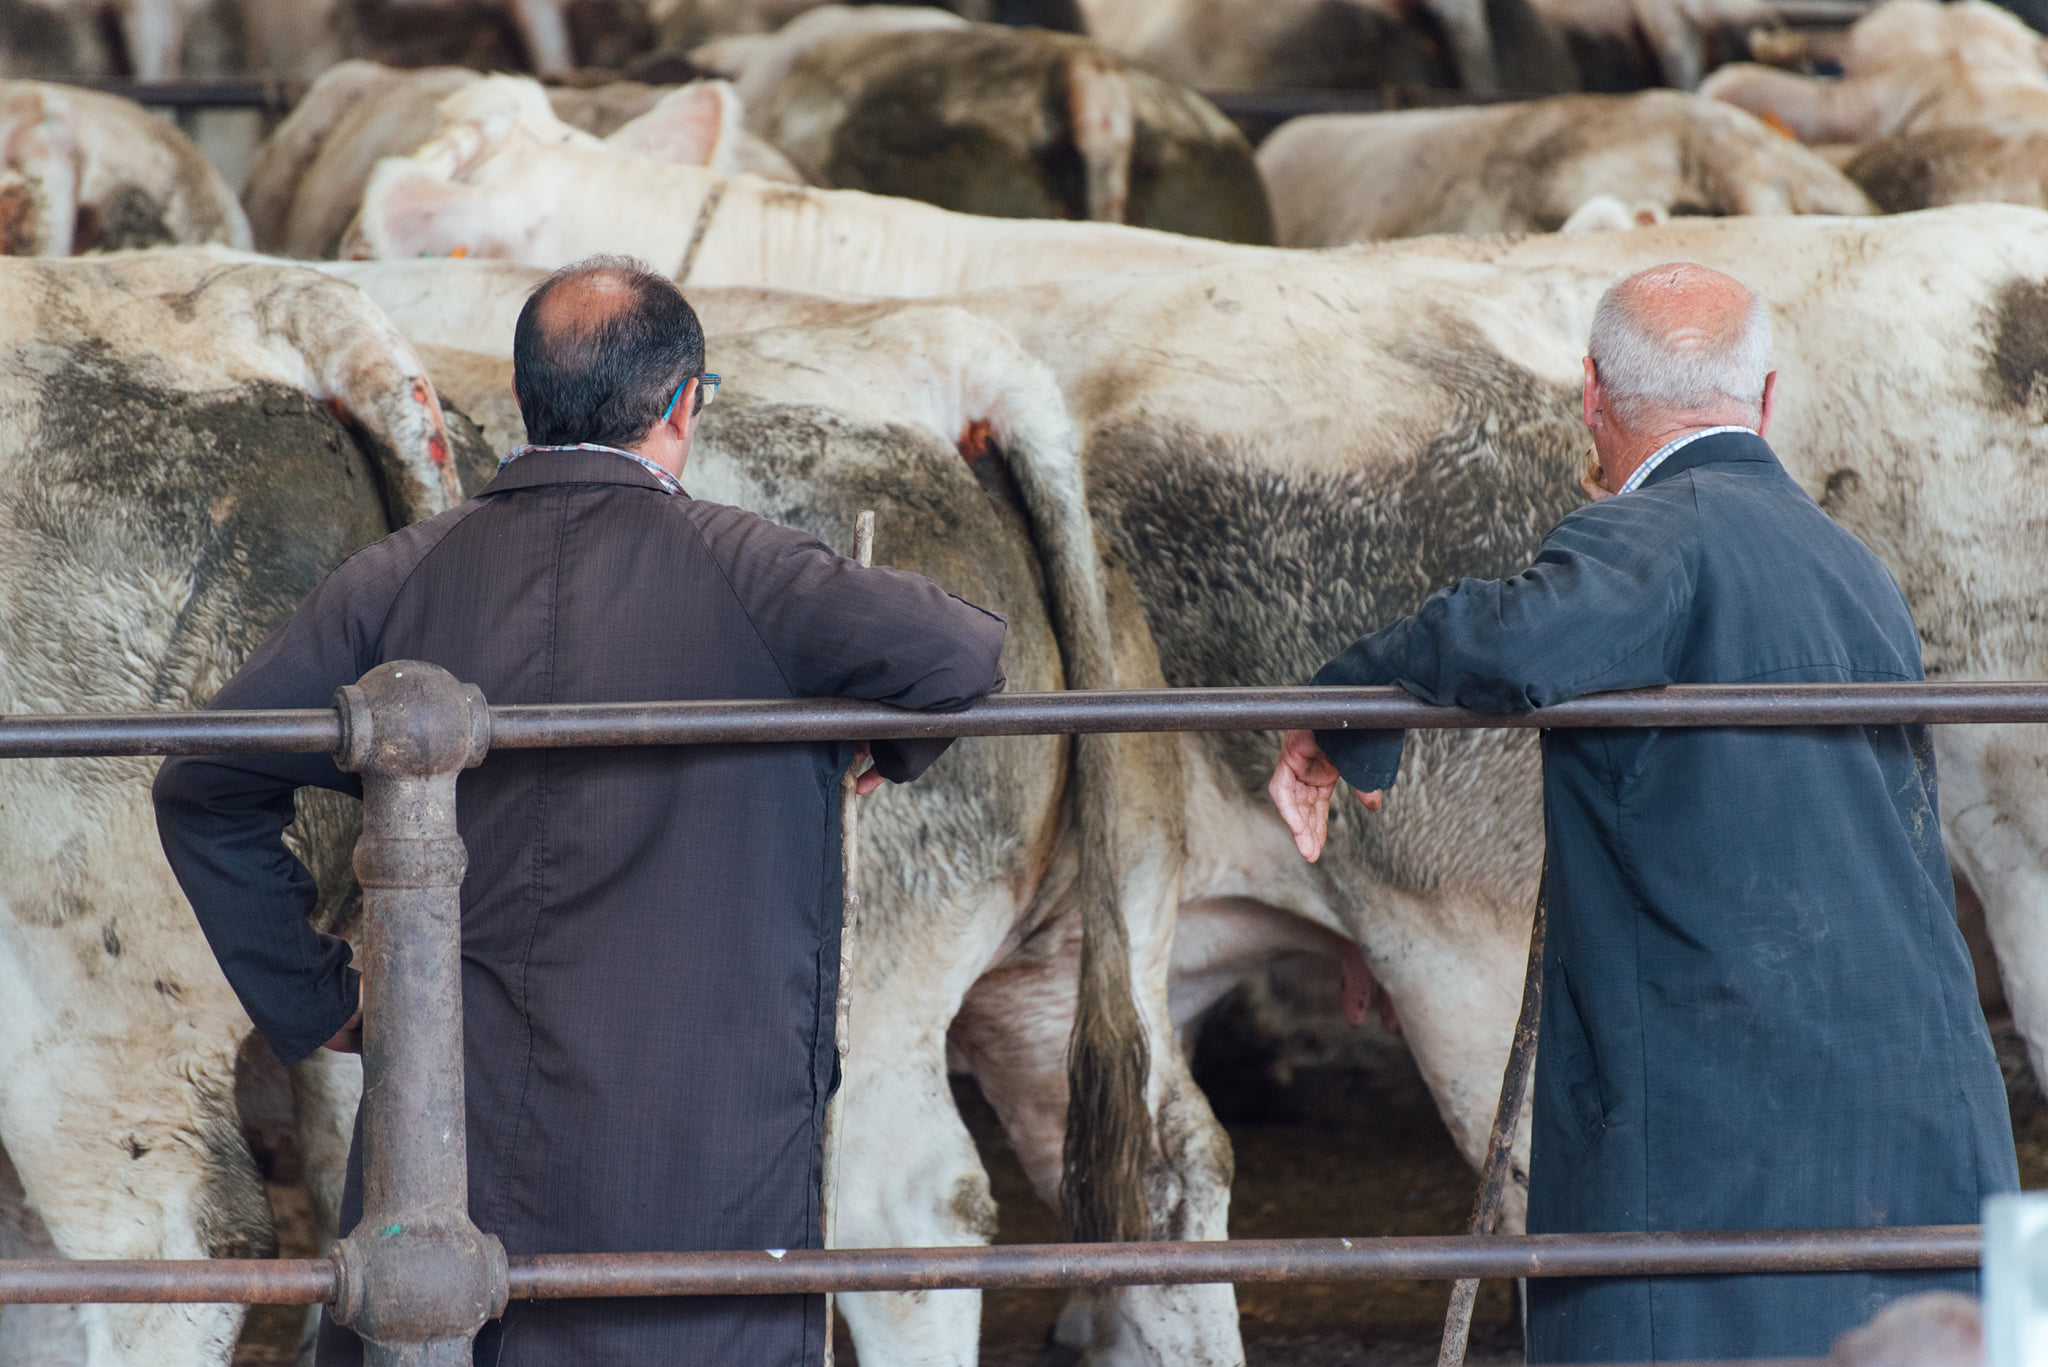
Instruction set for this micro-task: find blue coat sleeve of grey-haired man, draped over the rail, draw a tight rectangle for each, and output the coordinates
[1313,490,1696,791]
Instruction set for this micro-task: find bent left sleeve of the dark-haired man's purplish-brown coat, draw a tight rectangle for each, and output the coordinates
[154,557,389,1064]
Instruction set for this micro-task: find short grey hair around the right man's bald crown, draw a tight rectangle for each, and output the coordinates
[1587,266,1772,424]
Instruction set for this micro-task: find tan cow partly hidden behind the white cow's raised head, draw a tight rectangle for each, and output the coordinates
[242,61,801,258]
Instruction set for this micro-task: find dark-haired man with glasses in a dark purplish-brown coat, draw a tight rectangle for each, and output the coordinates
[156,260,1004,1367]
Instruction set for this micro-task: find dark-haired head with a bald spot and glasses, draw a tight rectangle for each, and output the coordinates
[512,256,705,447]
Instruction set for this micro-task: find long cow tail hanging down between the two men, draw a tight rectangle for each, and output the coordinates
[974,363,1153,1242]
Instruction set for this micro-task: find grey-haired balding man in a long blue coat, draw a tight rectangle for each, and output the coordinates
[1270,264,2017,1363]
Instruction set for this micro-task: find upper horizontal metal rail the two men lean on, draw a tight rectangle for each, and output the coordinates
[0,680,2048,758]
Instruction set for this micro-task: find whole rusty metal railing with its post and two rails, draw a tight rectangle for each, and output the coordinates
[0,662,2048,1367]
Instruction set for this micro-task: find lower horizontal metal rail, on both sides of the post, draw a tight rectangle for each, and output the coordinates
[0,1226,1982,1306]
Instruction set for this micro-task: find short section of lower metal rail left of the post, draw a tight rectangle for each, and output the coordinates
[0,1258,334,1306]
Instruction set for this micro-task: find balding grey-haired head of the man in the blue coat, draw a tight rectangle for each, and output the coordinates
[1589,262,1772,430]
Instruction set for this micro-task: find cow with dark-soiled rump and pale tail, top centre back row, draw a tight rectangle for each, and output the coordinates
[700,6,1272,242]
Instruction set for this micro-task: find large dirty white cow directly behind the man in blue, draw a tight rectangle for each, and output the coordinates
[663,207,2048,1262]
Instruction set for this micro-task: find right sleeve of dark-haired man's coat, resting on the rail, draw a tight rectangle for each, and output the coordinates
[707,510,1010,783]
